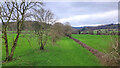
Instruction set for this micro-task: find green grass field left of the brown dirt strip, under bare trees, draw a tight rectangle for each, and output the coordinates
[2,35,102,66]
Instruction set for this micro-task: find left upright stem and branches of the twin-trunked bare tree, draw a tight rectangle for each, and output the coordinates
[0,2,15,60]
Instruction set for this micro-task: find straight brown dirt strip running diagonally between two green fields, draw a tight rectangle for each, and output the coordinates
[71,37,104,60]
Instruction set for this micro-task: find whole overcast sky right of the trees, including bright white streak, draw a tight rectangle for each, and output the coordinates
[45,2,118,27]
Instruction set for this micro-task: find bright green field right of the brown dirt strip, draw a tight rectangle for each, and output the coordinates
[72,34,114,52]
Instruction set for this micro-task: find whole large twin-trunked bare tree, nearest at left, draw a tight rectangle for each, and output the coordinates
[0,0,42,61]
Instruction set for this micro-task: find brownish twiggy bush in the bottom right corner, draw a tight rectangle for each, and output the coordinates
[103,36,120,66]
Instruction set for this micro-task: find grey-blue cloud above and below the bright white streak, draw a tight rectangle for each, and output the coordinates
[46,2,118,26]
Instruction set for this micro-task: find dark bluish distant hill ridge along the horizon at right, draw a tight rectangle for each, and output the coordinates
[72,24,118,31]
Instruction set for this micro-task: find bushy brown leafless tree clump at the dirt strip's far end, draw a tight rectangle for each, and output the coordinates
[49,22,72,44]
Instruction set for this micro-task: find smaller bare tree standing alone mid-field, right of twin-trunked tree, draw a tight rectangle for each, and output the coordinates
[33,8,54,50]
